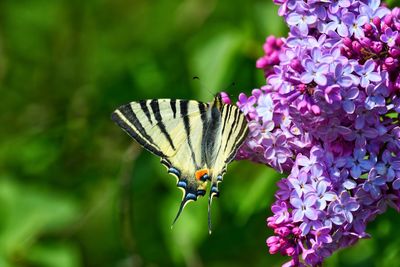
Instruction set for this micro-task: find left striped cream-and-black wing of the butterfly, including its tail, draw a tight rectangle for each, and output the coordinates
[112,99,209,222]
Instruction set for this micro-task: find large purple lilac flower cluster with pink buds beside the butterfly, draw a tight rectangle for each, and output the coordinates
[237,0,400,266]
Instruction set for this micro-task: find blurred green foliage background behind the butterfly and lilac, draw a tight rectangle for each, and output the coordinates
[0,0,400,267]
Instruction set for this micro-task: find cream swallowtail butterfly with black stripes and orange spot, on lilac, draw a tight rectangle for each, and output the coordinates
[111,94,248,233]
